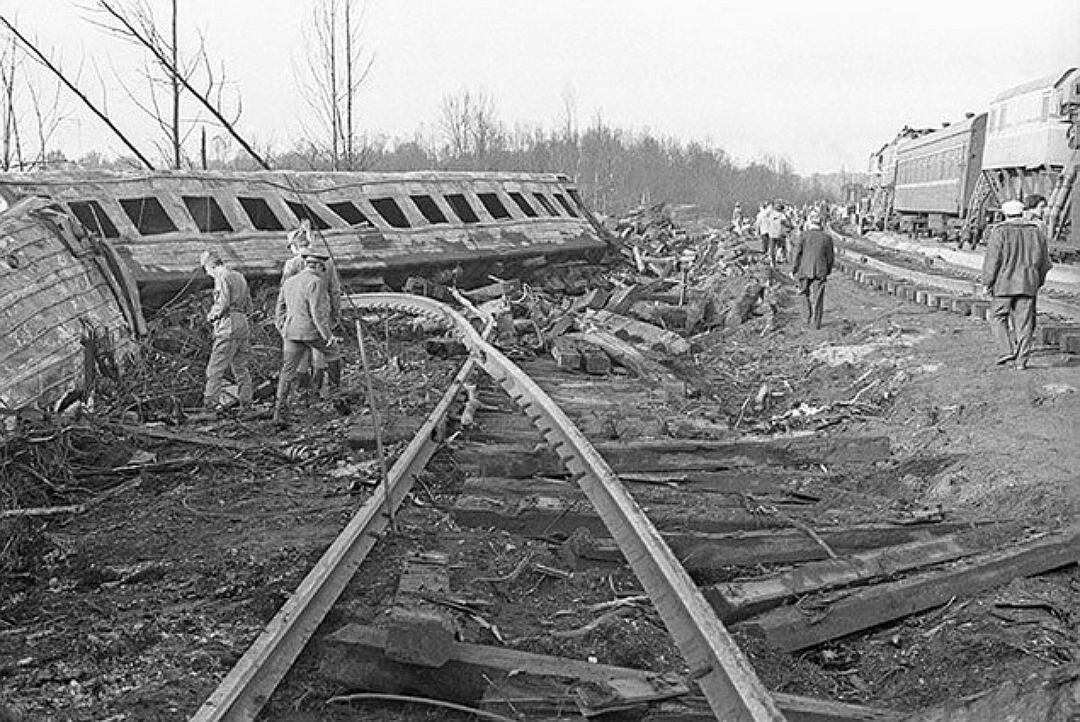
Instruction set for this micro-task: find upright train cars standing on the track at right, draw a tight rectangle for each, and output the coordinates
[861,68,1080,250]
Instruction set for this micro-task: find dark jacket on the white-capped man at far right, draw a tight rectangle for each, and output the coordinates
[983,218,1051,296]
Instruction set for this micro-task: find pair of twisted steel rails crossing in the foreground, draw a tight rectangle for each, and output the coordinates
[192,294,784,722]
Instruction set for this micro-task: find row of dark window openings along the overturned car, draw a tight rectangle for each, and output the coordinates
[68,189,584,239]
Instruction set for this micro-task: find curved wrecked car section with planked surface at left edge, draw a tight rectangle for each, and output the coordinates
[0,199,145,418]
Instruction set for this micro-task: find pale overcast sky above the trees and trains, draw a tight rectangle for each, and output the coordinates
[0,0,1080,174]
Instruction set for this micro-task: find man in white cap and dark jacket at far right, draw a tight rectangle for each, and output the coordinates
[982,201,1051,369]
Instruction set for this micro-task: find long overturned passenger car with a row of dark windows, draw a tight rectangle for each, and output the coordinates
[0,171,606,302]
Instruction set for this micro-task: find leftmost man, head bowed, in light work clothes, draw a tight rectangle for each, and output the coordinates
[200,250,252,412]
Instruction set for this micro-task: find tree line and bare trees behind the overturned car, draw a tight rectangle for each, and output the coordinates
[0,0,847,218]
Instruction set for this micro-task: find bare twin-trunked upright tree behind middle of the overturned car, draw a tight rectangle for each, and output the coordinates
[298,0,375,171]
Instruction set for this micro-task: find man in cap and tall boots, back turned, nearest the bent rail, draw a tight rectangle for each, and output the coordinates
[273,250,337,425]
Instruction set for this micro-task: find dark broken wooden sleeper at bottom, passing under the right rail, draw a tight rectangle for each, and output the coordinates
[320,625,899,722]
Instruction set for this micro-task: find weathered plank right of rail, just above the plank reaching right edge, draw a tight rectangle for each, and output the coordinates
[702,525,1020,622]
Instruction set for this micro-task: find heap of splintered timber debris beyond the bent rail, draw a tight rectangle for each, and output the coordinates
[405,199,783,379]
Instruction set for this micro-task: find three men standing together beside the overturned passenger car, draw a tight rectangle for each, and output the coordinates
[200,223,341,426]
